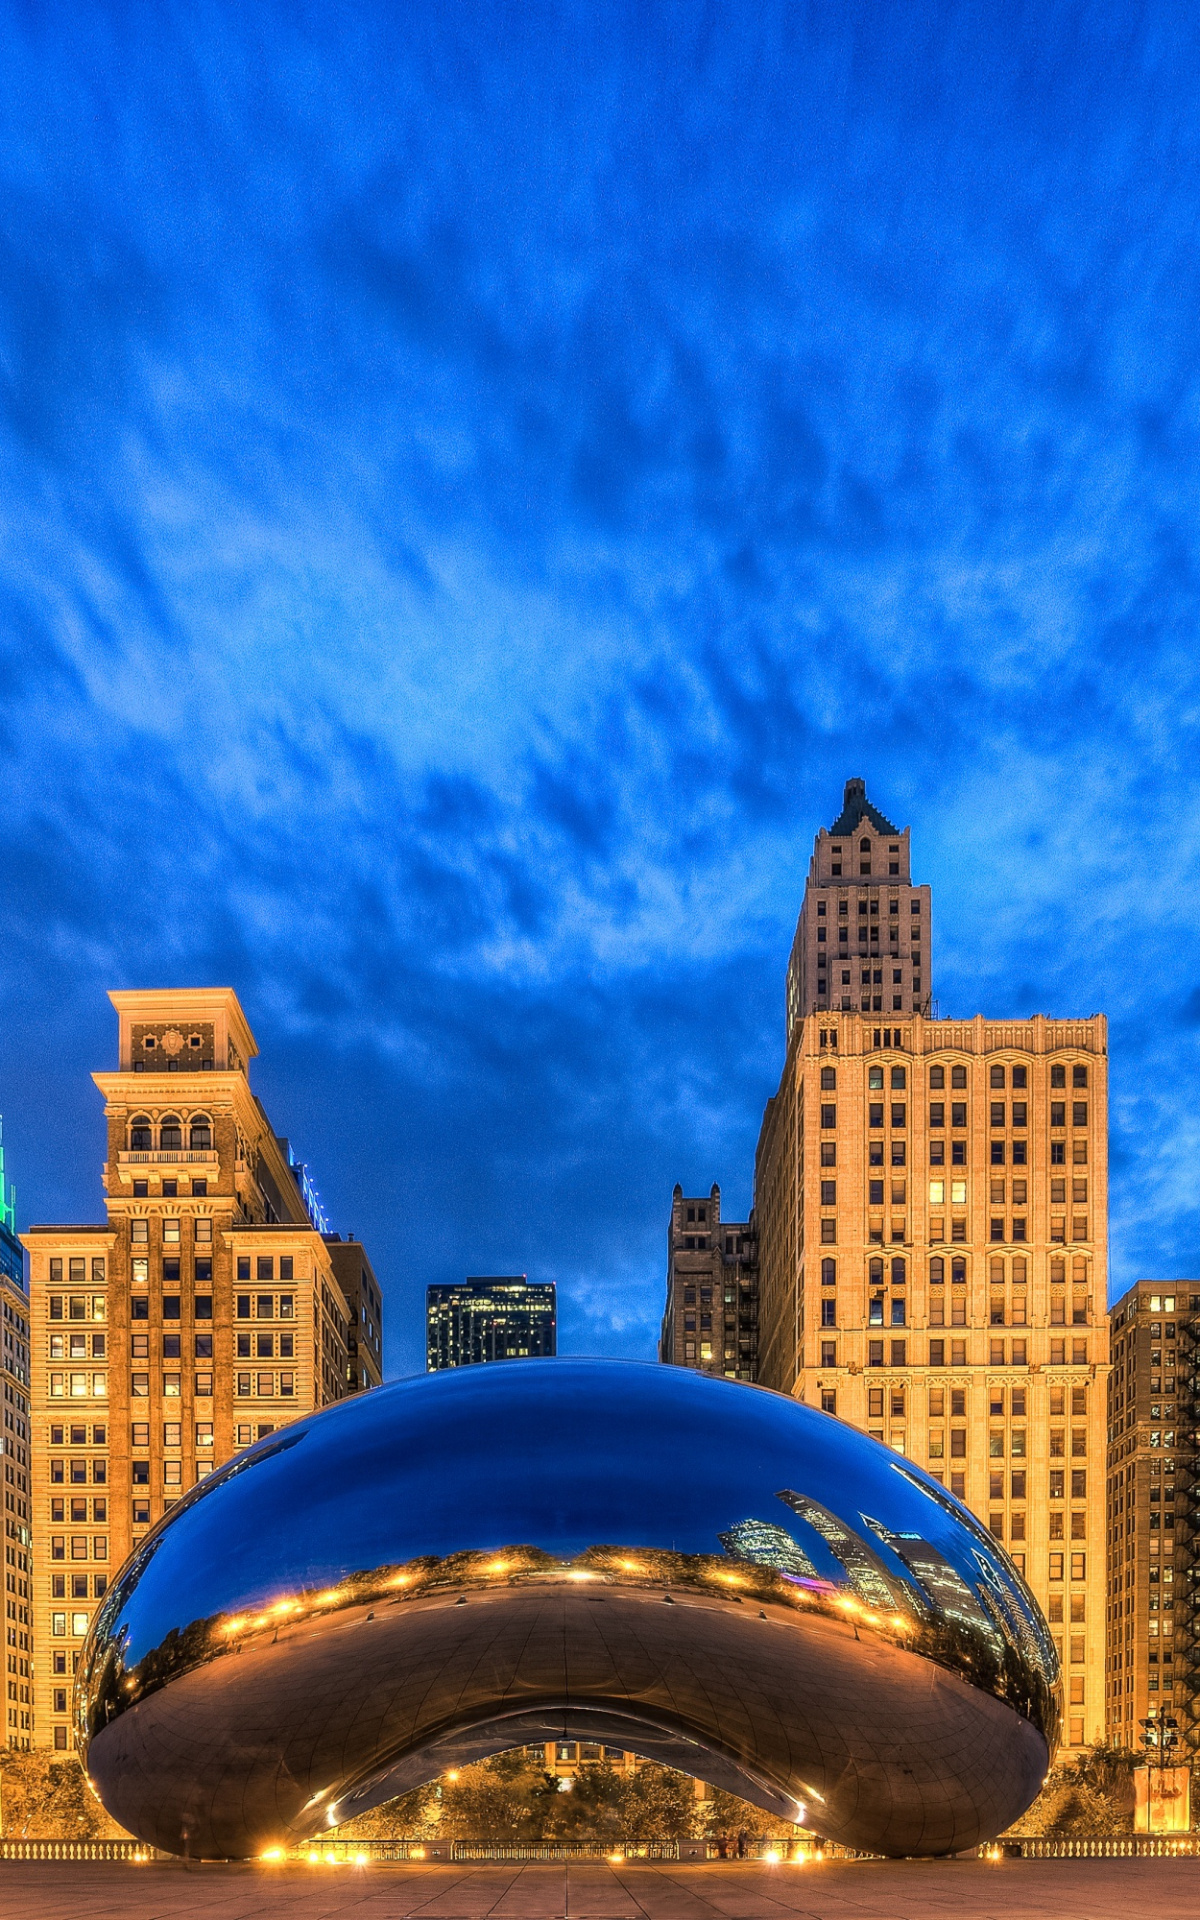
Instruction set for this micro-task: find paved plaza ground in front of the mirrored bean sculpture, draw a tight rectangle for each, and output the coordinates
[0,1860,1200,1920]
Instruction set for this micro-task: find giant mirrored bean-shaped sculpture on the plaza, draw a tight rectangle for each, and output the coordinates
[75,1359,1060,1857]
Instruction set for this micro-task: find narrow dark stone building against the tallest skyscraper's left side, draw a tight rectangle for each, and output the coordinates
[659,1183,758,1380]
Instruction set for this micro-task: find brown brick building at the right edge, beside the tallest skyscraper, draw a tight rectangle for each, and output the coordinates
[1106,1281,1200,1747]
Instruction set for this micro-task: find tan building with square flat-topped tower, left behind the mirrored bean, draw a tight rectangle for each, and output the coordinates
[23,989,382,1749]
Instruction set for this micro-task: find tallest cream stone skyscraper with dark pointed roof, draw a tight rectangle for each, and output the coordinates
[755,781,1108,1749]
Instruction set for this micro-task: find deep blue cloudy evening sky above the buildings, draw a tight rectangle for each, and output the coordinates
[0,0,1200,1373]
